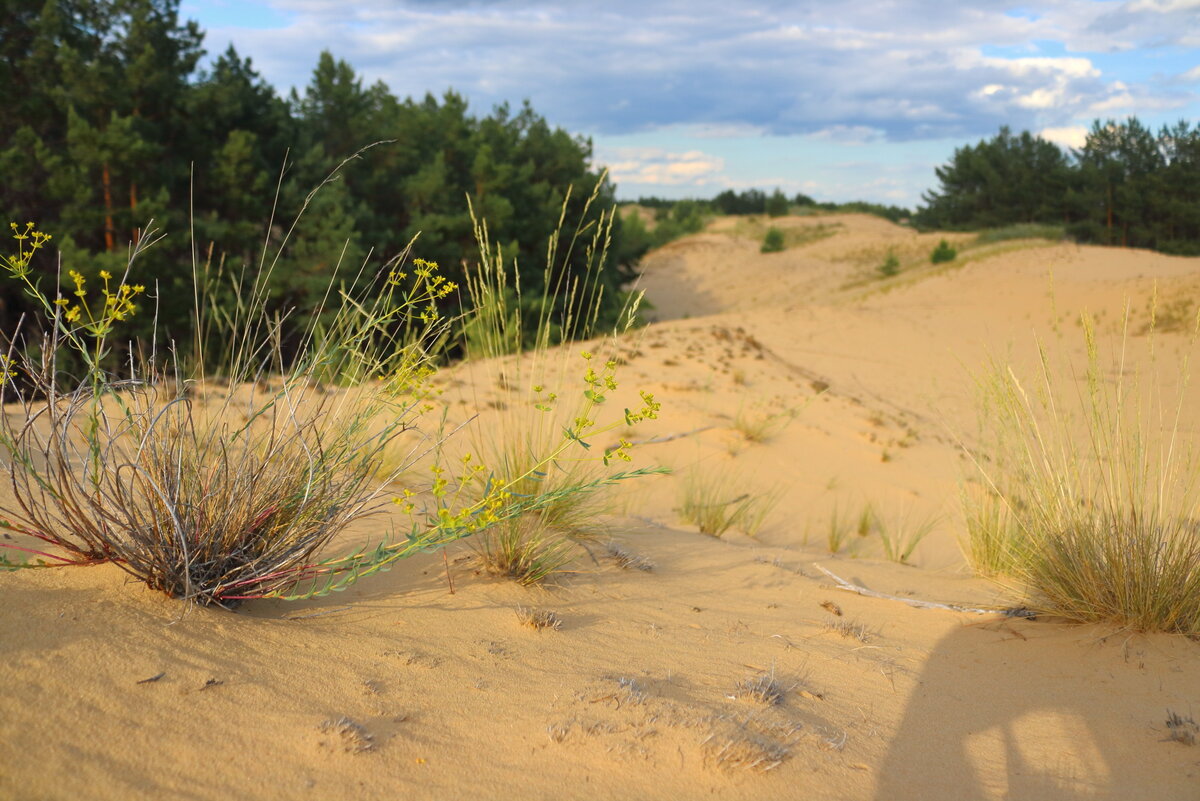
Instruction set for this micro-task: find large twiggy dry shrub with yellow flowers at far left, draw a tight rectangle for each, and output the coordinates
[0,215,470,606]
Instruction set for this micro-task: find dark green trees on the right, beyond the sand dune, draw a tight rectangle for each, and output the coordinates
[914,118,1200,255]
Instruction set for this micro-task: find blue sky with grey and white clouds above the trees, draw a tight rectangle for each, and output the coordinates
[181,0,1200,205]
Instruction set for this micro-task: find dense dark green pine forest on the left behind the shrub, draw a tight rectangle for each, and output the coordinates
[0,0,630,359]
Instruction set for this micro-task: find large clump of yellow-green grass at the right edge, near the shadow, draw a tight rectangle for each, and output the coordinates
[964,304,1200,634]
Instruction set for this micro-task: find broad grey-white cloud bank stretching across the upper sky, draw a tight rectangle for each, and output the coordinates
[196,0,1200,141]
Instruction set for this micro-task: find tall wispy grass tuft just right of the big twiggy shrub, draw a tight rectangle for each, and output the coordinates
[464,189,662,585]
